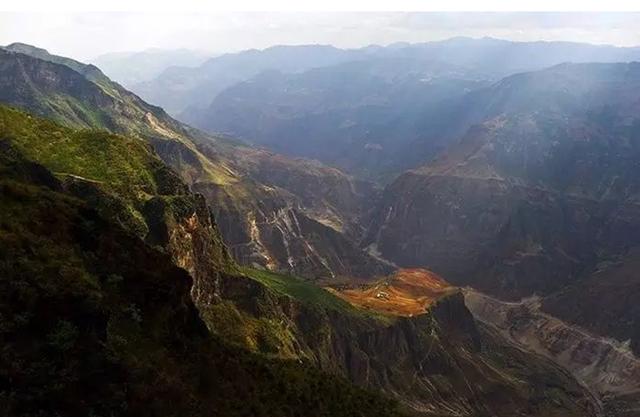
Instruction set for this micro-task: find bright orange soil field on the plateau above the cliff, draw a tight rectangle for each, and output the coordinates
[330,269,455,316]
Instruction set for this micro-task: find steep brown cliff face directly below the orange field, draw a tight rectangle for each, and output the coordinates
[208,266,599,417]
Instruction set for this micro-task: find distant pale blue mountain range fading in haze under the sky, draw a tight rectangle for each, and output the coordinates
[126,38,640,178]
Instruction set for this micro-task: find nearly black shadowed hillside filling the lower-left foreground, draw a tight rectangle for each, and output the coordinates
[0,140,397,417]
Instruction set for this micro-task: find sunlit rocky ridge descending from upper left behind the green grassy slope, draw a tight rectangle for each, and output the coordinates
[0,43,388,278]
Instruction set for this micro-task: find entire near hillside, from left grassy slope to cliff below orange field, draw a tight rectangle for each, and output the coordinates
[0,103,597,416]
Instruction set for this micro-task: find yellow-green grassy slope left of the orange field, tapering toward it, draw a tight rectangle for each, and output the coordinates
[202,267,394,363]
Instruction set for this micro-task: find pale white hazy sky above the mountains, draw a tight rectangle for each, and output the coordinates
[0,12,640,60]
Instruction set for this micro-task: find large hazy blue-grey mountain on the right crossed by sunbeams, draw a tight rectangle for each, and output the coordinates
[367,63,640,299]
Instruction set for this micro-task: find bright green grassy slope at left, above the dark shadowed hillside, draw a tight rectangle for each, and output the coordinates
[0,105,195,237]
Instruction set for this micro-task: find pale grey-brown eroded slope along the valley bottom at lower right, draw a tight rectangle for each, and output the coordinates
[465,290,640,416]
